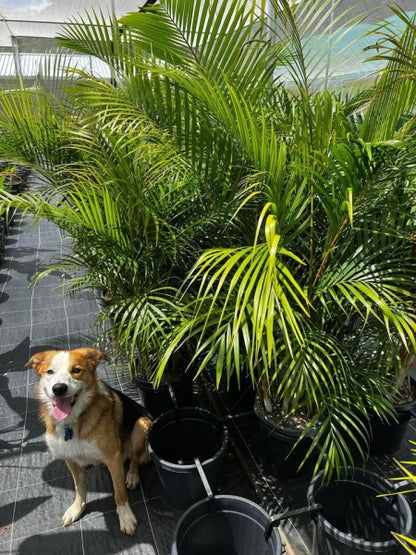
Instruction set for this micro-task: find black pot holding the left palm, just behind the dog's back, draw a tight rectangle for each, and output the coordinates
[133,374,193,418]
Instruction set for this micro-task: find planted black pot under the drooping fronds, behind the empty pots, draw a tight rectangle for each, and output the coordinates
[255,405,312,479]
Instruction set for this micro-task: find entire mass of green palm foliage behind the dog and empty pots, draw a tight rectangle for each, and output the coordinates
[0,0,416,482]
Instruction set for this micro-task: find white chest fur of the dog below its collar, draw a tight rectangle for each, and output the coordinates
[46,430,103,466]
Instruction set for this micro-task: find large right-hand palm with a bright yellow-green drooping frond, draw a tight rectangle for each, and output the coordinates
[109,0,415,474]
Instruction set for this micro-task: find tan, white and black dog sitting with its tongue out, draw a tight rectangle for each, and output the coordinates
[26,348,151,535]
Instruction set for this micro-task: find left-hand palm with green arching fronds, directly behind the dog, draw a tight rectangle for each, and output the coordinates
[0,54,218,375]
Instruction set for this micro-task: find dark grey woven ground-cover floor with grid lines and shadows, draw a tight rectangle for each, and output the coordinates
[0,175,416,555]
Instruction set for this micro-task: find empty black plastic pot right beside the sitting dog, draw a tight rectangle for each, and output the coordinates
[147,407,228,509]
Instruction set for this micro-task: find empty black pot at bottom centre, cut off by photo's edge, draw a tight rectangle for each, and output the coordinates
[171,495,282,555]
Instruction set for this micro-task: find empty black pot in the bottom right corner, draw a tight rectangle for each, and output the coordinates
[307,468,412,555]
